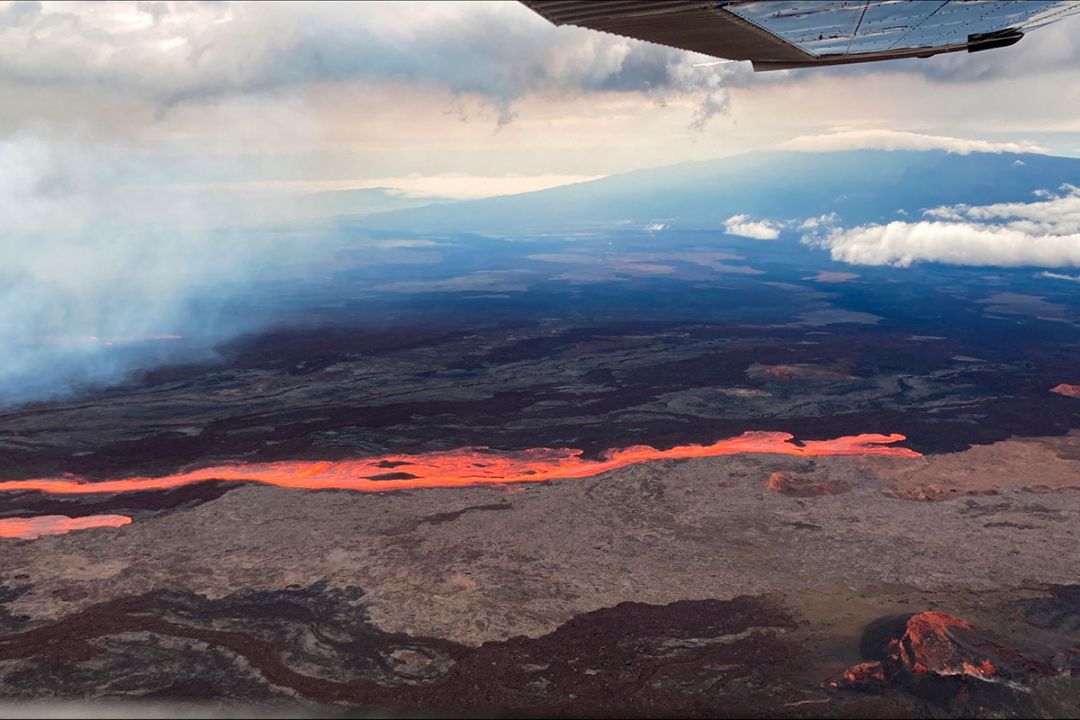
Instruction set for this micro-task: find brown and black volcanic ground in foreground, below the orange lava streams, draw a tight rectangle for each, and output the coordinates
[0,454,1080,717]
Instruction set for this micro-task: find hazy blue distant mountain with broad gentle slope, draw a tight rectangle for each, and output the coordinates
[363,150,1080,232]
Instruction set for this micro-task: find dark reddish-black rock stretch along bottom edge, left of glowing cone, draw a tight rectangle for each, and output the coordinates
[0,582,806,717]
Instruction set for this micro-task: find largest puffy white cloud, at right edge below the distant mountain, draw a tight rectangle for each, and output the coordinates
[804,186,1080,268]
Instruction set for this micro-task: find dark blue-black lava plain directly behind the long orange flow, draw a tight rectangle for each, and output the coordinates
[0,321,1080,479]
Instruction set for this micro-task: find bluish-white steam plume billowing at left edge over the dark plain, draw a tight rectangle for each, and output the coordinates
[0,136,311,404]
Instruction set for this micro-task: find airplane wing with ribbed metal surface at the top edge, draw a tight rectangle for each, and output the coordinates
[523,0,1080,70]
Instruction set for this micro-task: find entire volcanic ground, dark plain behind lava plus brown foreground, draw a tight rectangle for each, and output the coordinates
[0,322,1080,717]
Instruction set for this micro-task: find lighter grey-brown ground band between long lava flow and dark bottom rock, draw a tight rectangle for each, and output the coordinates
[2,454,1080,644]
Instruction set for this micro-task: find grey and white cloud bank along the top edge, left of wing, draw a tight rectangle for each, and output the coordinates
[0,2,751,126]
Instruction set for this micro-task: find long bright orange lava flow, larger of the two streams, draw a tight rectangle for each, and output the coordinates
[0,432,919,495]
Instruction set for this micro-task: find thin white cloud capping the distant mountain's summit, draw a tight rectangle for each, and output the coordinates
[778,130,1047,155]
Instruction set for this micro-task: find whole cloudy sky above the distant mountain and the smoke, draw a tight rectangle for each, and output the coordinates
[6,2,1080,205]
